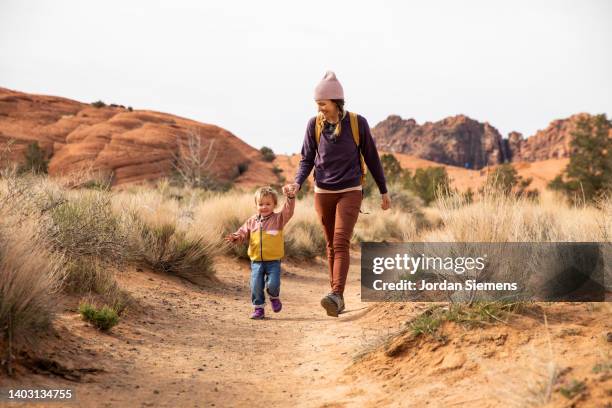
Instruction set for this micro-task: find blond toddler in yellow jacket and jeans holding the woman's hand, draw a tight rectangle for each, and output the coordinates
[225,187,295,319]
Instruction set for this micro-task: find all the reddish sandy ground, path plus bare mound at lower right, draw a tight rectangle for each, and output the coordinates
[0,253,612,408]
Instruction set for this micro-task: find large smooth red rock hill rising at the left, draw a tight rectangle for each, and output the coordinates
[0,88,276,187]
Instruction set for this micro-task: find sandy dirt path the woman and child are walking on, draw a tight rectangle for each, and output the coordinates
[1,253,416,407]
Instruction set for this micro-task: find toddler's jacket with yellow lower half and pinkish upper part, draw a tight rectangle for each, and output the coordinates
[236,197,295,261]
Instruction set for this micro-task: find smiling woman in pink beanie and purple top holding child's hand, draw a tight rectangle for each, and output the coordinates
[283,71,391,317]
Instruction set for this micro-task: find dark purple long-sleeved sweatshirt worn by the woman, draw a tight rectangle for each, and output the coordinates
[295,112,387,194]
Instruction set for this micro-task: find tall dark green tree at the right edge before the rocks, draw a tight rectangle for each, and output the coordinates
[548,114,612,202]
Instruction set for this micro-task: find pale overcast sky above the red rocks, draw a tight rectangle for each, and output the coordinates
[0,0,612,153]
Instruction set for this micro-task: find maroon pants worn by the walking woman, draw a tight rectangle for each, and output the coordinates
[315,191,362,295]
